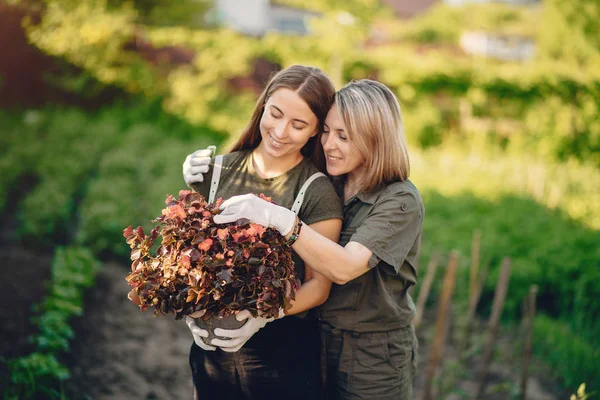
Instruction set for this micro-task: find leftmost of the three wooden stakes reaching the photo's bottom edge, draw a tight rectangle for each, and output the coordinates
[422,251,458,400]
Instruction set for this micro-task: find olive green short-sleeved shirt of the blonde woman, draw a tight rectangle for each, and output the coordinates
[319,180,425,332]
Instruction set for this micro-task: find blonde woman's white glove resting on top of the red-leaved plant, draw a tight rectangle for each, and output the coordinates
[213,194,296,236]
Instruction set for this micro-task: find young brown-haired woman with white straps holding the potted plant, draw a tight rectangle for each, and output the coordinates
[186,65,342,399]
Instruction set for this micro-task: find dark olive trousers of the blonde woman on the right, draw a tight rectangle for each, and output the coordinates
[321,324,417,400]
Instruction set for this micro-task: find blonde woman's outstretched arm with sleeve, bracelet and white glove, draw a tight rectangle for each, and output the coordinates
[214,193,422,285]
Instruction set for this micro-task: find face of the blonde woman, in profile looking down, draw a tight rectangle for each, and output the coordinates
[321,104,363,176]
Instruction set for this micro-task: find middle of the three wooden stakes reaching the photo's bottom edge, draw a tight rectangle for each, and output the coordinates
[476,257,510,399]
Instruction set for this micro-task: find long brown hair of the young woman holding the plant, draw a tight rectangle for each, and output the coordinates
[230,65,335,172]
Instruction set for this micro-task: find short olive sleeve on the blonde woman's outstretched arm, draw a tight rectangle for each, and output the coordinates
[350,191,423,275]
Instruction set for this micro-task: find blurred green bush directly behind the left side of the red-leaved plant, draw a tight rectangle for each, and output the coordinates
[77,121,221,256]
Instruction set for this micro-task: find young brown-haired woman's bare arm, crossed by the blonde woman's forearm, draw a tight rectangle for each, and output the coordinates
[286,219,342,315]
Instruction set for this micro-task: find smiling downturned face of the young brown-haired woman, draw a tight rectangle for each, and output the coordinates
[260,88,318,157]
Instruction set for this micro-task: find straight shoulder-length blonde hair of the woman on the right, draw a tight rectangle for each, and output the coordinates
[334,79,410,192]
